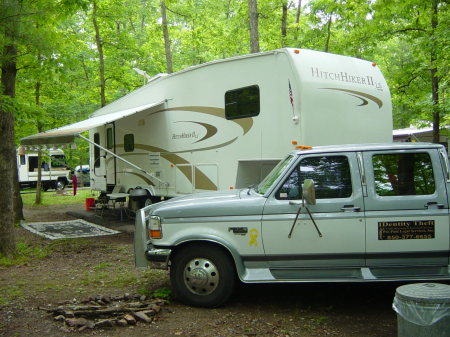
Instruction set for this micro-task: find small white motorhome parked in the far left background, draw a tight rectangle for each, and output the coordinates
[17,149,70,190]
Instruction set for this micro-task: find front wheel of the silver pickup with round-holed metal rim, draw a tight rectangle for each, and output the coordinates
[170,245,235,308]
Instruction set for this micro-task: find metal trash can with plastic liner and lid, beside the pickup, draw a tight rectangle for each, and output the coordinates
[392,283,450,337]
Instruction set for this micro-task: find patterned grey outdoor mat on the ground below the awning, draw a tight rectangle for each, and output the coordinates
[21,219,120,240]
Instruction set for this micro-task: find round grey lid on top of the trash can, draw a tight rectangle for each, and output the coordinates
[395,283,450,304]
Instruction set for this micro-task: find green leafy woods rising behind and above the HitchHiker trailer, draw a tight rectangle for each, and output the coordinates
[0,0,450,253]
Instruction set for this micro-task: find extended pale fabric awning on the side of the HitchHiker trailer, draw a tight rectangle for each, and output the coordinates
[20,100,166,145]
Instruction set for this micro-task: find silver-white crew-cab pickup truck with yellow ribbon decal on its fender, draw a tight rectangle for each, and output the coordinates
[135,143,450,307]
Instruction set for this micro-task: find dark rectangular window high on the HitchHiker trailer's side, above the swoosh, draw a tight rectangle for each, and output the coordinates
[225,85,259,119]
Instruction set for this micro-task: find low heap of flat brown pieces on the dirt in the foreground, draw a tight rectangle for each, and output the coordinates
[39,294,165,331]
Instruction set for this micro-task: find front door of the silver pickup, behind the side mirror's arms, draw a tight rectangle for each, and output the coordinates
[262,152,365,279]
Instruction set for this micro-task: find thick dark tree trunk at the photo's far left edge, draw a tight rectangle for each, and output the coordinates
[0,34,20,256]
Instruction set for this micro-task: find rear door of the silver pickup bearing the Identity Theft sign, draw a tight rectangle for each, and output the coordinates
[363,149,449,270]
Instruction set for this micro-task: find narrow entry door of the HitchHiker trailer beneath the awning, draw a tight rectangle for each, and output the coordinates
[90,127,106,191]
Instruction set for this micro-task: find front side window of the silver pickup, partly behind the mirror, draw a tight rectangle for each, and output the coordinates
[276,156,352,200]
